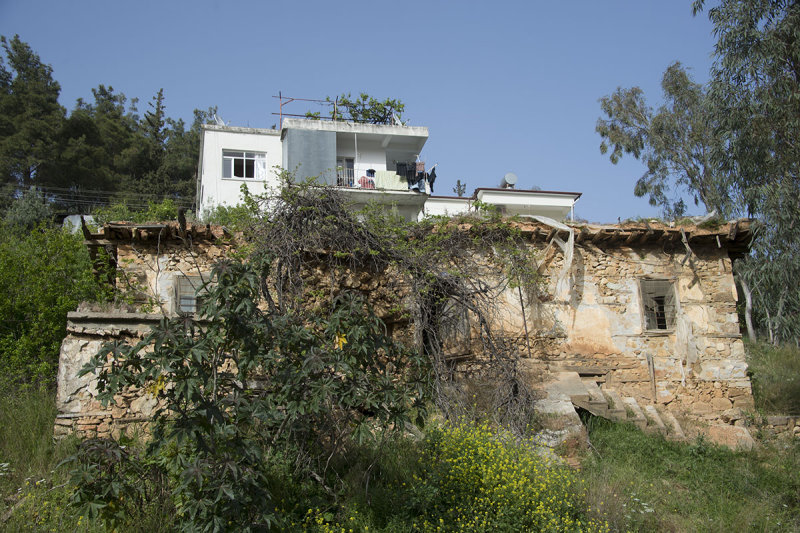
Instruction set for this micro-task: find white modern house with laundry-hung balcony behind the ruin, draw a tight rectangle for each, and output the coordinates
[197,119,581,220]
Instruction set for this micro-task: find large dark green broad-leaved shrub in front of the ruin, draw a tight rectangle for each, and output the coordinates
[74,258,426,531]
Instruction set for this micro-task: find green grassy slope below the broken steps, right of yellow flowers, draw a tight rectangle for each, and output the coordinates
[581,418,800,532]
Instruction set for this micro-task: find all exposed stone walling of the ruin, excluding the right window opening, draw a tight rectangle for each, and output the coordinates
[56,218,764,442]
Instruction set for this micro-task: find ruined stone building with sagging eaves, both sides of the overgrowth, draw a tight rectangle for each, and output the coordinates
[55,219,753,445]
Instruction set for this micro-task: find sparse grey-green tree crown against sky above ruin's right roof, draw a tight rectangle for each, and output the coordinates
[596,62,730,218]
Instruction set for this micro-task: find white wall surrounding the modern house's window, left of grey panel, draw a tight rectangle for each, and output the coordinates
[198,126,283,216]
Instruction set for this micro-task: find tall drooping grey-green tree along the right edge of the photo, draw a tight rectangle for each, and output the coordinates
[694,0,800,342]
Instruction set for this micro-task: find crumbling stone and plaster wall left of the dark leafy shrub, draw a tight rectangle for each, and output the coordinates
[54,239,232,437]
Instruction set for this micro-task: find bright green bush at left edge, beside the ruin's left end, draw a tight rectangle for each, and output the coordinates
[0,220,105,389]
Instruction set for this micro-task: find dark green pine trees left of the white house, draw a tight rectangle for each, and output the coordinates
[0,36,215,208]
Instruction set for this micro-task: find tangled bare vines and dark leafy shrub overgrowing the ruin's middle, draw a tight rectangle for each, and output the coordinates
[73,182,538,531]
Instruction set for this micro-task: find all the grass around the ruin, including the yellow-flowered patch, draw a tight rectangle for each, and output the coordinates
[0,344,800,532]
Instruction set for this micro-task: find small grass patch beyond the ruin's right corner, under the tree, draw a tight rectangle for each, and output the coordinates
[746,342,800,415]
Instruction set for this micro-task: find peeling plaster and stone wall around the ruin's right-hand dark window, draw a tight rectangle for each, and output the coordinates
[494,239,753,426]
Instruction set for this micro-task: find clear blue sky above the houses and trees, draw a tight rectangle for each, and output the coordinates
[0,0,714,222]
